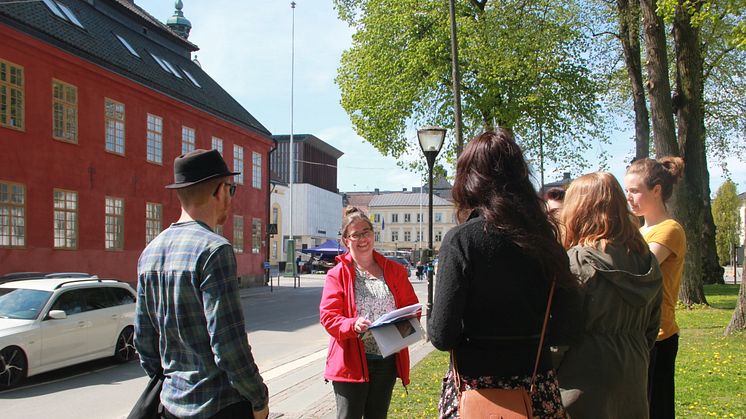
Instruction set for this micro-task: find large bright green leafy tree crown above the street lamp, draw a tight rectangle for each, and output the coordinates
[335,0,601,165]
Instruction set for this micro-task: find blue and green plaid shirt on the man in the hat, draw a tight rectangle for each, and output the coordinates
[135,221,268,418]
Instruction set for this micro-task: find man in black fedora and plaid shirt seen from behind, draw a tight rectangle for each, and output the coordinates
[135,150,269,419]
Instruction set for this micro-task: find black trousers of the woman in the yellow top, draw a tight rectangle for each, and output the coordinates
[648,334,679,419]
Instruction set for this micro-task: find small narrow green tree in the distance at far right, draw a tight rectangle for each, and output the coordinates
[712,179,741,266]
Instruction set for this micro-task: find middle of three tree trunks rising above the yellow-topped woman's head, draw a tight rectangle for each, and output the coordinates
[640,0,679,157]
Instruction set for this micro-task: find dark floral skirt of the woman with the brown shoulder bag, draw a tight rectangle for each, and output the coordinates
[438,368,567,419]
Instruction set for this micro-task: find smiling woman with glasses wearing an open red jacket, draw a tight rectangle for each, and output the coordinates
[319,207,418,419]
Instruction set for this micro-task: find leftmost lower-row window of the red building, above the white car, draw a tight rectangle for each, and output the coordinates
[0,181,26,247]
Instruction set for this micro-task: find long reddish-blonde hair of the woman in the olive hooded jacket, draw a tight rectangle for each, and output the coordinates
[562,172,648,253]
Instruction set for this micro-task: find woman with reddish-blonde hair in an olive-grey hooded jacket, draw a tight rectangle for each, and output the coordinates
[557,172,662,419]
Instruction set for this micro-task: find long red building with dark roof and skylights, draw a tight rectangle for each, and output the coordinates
[0,0,272,285]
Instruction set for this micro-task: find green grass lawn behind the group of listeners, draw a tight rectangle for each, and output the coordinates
[389,285,746,419]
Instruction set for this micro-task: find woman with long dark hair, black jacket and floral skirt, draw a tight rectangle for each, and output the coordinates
[428,129,577,418]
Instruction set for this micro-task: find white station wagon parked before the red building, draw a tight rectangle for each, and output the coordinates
[0,276,136,390]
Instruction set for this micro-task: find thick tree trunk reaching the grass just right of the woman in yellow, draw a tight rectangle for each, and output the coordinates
[673,0,710,306]
